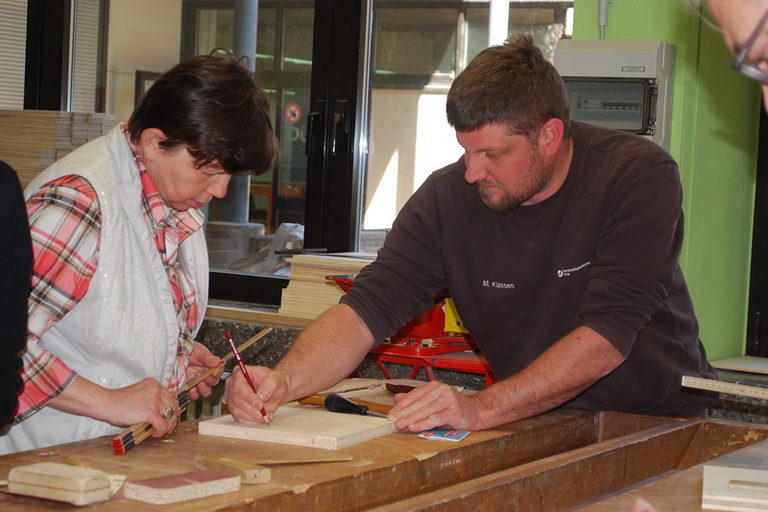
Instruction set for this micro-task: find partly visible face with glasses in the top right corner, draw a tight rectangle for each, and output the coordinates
[707,0,768,110]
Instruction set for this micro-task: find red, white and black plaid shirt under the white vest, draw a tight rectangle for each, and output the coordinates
[15,131,203,422]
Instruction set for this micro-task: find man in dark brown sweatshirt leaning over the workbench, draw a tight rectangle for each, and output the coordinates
[227,36,715,431]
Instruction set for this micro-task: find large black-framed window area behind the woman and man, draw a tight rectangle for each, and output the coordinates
[22,0,573,304]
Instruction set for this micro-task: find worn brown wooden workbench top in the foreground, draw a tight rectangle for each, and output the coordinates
[0,410,768,512]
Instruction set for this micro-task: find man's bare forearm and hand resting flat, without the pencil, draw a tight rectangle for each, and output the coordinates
[390,326,625,432]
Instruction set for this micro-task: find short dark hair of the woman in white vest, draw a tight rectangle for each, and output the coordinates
[128,56,278,174]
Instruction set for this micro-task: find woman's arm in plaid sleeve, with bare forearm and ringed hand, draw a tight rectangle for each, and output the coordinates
[16,176,178,435]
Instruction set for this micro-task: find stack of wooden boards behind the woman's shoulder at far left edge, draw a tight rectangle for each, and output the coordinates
[0,110,115,186]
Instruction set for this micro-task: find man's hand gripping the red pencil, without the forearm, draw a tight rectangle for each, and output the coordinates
[224,366,290,423]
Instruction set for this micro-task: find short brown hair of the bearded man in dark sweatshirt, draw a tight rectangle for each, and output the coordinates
[446,34,570,137]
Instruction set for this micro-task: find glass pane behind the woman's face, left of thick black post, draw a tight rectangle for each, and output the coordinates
[182,0,314,284]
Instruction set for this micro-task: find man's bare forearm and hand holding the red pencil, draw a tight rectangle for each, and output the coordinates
[226,304,374,423]
